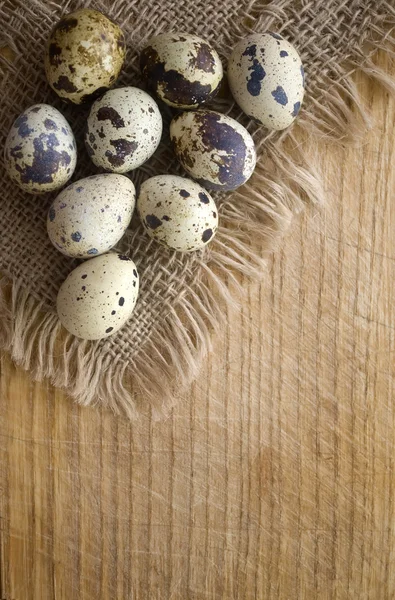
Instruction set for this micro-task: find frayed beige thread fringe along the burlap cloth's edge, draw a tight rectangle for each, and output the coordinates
[0,30,395,419]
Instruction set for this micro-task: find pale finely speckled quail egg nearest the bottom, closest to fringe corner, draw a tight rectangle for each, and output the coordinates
[57,252,139,340]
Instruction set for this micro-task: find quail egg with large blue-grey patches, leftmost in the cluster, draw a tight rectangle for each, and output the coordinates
[4,104,77,194]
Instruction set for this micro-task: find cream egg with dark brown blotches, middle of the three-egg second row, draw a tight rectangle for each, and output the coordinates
[85,87,162,173]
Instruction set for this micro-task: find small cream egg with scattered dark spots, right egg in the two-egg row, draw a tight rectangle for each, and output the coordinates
[137,175,218,252]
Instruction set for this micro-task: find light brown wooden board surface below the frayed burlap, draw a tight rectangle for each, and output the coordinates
[0,63,395,600]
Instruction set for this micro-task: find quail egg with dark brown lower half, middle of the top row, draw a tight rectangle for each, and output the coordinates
[140,33,223,108]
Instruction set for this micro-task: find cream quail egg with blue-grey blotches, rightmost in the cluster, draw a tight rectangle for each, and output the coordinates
[228,32,305,130]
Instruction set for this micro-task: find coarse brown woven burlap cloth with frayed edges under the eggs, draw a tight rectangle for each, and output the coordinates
[0,0,395,416]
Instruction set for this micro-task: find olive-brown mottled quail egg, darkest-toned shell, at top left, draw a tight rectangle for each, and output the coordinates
[44,8,125,104]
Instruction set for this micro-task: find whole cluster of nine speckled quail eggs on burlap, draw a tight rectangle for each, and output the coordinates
[4,9,304,340]
